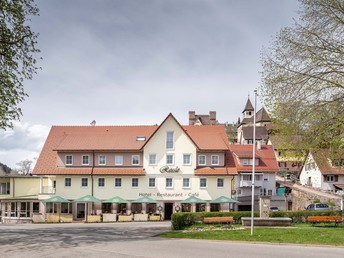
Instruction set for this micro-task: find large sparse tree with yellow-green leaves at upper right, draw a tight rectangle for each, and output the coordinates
[260,0,344,151]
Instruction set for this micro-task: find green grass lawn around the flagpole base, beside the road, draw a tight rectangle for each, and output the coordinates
[159,224,344,246]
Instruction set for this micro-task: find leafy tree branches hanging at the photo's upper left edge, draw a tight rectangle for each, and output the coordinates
[0,0,40,129]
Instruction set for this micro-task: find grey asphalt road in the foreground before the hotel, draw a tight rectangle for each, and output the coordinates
[0,222,344,258]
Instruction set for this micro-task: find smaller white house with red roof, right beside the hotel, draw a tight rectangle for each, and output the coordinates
[228,144,278,211]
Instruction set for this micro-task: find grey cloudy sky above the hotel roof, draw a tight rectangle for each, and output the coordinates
[0,0,299,168]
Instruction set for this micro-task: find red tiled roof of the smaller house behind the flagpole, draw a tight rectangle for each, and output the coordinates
[230,144,279,173]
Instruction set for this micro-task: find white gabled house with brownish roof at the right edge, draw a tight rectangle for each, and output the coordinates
[299,149,344,193]
